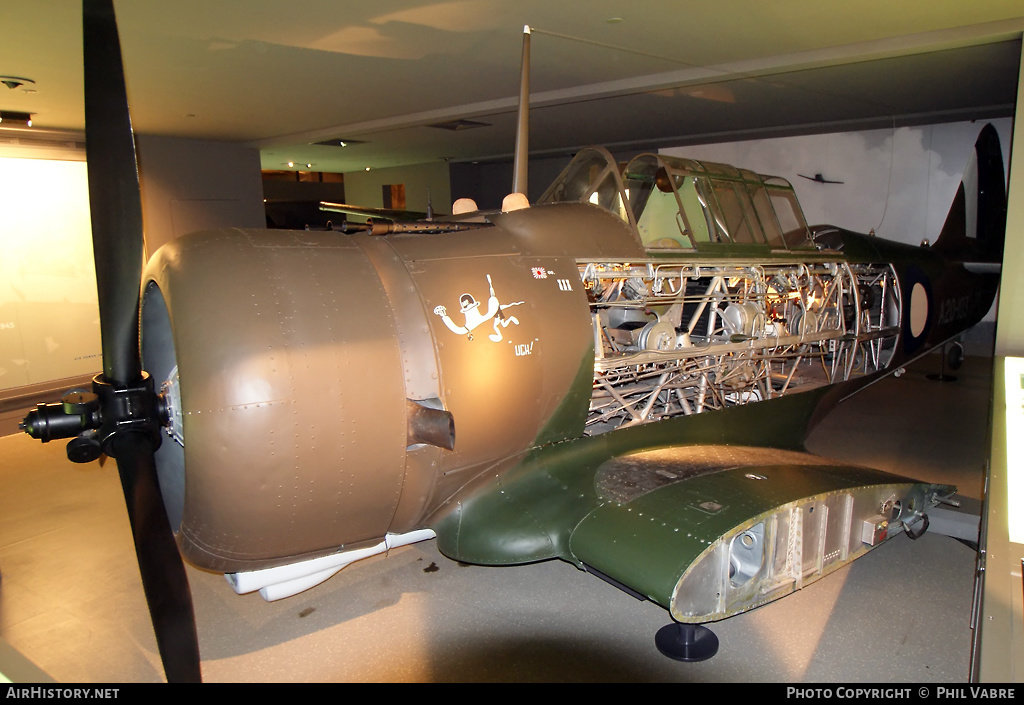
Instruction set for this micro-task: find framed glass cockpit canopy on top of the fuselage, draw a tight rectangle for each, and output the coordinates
[539,148,814,250]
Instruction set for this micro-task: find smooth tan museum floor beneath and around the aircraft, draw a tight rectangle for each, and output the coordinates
[0,356,991,683]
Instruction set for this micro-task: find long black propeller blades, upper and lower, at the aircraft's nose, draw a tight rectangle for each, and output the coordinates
[82,0,202,682]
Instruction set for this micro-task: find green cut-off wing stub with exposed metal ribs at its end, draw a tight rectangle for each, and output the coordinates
[437,445,955,623]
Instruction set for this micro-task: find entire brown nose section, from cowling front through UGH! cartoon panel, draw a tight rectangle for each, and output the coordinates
[141,207,614,573]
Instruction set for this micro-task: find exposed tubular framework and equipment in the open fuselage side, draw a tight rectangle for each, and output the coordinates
[581,260,899,433]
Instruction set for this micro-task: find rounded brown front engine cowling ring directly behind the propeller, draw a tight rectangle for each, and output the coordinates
[142,231,407,571]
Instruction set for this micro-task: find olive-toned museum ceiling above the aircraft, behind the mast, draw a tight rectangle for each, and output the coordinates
[0,0,1024,171]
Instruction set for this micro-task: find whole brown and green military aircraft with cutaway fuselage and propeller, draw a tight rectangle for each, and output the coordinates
[24,0,1006,680]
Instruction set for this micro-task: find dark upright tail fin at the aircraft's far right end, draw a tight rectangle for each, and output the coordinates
[933,124,1007,263]
